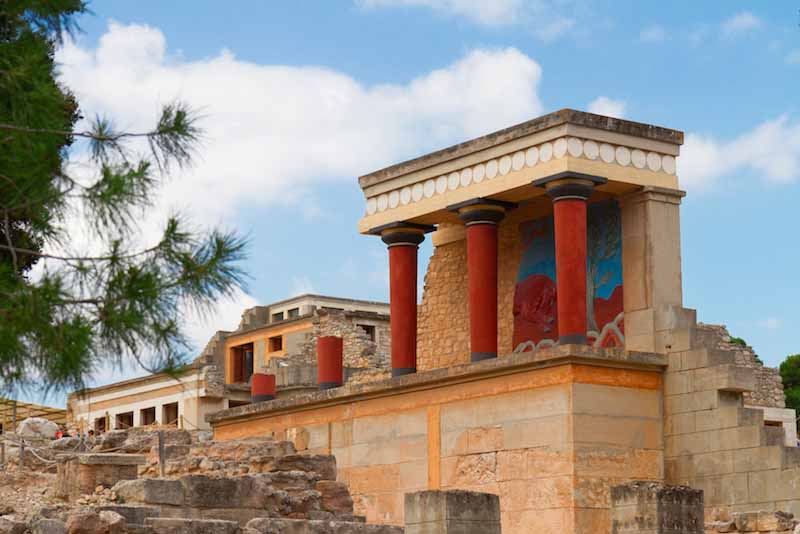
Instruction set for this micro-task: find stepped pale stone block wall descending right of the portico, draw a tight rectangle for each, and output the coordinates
[664,324,800,521]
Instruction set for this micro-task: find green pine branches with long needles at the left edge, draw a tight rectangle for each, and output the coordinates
[0,0,246,398]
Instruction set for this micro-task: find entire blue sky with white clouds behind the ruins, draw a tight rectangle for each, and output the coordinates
[25,0,800,404]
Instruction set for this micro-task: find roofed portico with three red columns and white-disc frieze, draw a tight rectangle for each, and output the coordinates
[359,110,683,364]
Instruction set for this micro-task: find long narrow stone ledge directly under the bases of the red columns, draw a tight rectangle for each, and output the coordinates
[206,344,667,425]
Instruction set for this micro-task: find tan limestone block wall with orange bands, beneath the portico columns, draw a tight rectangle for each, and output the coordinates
[214,347,664,534]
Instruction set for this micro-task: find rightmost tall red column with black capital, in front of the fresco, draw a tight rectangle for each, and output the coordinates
[534,172,606,345]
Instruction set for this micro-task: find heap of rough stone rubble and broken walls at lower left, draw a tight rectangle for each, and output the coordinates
[0,429,403,534]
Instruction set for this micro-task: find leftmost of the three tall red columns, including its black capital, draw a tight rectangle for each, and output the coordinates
[373,223,433,376]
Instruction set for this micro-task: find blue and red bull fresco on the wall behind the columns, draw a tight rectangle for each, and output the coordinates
[513,200,625,352]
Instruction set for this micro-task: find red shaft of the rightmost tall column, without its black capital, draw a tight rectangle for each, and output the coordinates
[553,198,587,344]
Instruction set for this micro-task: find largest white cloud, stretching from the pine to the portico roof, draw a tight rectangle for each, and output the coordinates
[58,23,542,229]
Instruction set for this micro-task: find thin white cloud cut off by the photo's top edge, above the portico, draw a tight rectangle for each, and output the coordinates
[355,0,575,41]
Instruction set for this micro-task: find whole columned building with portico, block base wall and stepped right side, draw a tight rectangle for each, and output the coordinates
[207,110,800,534]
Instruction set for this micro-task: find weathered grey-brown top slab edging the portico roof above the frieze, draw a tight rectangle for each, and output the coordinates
[359,109,683,188]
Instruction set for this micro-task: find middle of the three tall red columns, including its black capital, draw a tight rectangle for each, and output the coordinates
[448,198,513,362]
